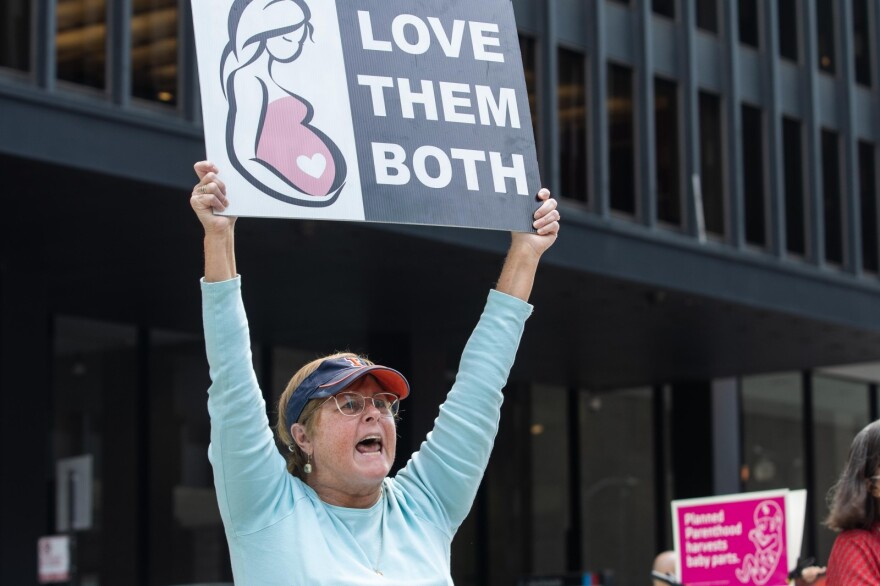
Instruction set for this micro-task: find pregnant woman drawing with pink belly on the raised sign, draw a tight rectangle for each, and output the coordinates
[220,0,346,207]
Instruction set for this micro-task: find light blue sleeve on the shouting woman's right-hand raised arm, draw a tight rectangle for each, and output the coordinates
[395,291,532,535]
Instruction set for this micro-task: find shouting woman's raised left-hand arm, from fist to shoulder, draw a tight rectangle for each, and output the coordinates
[190,162,291,534]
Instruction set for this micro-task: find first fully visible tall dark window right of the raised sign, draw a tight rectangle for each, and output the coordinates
[559,49,588,202]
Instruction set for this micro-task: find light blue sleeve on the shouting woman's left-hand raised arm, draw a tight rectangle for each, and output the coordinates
[202,277,291,535]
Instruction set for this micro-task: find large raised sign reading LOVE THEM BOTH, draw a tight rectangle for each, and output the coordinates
[192,0,540,231]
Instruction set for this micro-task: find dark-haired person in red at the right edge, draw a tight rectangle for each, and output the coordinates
[825,421,880,586]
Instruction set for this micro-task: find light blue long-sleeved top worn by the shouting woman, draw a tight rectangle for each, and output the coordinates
[202,277,532,586]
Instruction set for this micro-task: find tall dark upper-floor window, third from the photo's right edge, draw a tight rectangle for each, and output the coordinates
[782,118,807,256]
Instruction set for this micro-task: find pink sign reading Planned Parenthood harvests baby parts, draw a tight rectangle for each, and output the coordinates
[673,493,789,586]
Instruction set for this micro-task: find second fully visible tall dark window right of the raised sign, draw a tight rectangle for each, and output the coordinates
[607,64,636,214]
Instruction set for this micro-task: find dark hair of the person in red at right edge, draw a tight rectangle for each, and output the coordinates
[825,420,880,531]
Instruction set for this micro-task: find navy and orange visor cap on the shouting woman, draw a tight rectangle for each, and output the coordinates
[284,356,409,425]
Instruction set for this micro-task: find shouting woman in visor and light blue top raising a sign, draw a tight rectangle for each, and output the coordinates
[190,157,559,586]
